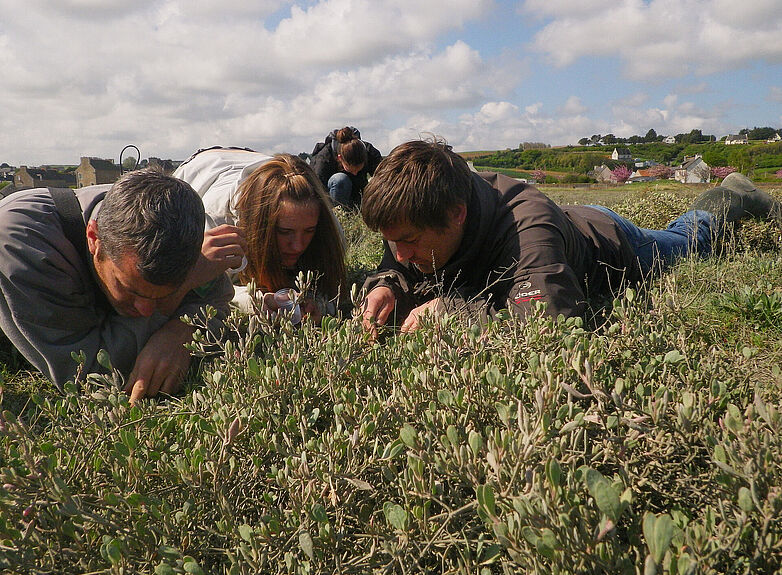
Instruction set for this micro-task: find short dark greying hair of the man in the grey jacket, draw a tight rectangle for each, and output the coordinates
[96,169,205,286]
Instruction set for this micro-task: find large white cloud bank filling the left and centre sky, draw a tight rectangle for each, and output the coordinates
[0,0,502,164]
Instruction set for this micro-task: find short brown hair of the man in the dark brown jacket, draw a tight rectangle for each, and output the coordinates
[361,139,472,231]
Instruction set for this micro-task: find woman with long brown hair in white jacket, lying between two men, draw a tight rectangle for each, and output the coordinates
[174,147,346,320]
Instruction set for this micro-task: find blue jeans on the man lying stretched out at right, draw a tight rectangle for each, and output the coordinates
[589,206,722,275]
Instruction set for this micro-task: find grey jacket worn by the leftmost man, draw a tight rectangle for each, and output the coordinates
[0,185,233,388]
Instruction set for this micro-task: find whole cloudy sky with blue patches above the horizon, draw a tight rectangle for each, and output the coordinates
[0,0,782,166]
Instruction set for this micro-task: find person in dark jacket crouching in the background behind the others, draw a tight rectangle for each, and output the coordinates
[311,126,383,209]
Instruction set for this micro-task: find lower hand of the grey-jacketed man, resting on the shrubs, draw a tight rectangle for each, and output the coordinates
[125,318,193,405]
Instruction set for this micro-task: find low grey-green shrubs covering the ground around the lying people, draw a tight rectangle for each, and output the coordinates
[0,184,782,574]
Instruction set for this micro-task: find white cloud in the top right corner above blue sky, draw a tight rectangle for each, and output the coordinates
[524,0,782,81]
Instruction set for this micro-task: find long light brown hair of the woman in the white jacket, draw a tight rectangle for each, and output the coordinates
[236,154,345,298]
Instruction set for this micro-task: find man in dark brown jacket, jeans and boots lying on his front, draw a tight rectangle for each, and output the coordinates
[361,141,782,332]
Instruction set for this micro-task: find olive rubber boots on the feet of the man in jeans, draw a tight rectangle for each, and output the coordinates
[690,172,782,222]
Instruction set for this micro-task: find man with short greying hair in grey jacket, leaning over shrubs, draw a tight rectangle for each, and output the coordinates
[0,166,234,401]
